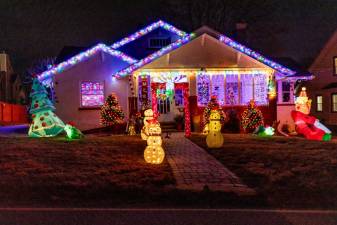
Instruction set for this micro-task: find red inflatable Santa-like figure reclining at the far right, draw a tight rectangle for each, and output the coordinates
[291,87,331,141]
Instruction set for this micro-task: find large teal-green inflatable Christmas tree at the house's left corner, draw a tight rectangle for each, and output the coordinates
[28,78,65,137]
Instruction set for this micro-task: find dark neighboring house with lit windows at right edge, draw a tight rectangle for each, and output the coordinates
[307,30,337,127]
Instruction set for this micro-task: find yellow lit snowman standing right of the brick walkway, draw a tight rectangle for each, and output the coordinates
[206,110,224,148]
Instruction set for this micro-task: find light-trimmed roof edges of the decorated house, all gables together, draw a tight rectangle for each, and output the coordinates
[38,20,310,80]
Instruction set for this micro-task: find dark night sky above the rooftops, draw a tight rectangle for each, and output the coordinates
[0,0,337,72]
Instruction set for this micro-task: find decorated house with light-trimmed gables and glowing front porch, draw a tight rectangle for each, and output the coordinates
[38,21,313,133]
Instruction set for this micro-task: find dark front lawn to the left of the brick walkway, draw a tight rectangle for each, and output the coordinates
[0,135,175,206]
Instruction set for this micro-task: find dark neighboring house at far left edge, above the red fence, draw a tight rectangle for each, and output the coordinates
[0,53,27,104]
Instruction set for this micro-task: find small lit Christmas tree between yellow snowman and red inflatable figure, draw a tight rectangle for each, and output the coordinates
[241,100,264,133]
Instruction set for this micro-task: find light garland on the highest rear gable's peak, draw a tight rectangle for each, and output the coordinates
[111,20,187,49]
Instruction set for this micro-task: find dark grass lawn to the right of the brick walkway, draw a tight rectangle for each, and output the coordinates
[191,134,337,209]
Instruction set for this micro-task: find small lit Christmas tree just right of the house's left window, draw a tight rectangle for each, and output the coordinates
[101,95,124,126]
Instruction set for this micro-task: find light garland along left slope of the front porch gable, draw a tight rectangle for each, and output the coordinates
[112,34,194,77]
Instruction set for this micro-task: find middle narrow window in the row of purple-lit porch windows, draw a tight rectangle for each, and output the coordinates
[226,74,239,105]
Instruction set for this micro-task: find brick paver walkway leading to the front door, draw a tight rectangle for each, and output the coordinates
[164,133,254,194]
